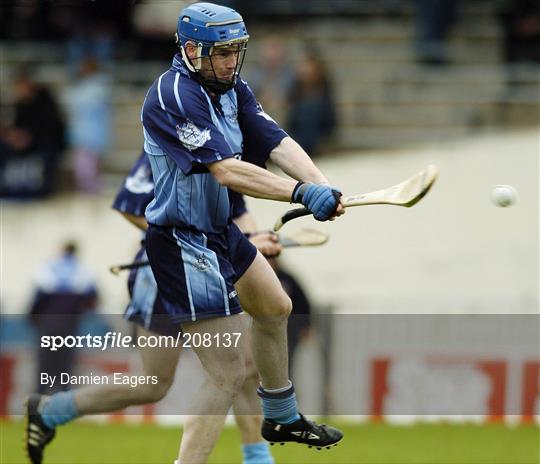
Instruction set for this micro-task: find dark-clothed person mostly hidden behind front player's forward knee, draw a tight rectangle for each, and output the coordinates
[268,258,311,379]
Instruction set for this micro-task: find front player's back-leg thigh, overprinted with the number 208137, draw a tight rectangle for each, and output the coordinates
[182,314,246,388]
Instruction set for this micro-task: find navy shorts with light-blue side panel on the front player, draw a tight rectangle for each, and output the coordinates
[146,224,257,323]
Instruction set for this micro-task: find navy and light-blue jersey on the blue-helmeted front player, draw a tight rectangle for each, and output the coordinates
[141,55,287,233]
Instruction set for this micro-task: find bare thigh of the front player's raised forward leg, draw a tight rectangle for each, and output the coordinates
[235,253,292,318]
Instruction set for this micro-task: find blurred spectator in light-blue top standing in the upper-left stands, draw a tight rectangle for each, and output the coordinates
[66,57,112,194]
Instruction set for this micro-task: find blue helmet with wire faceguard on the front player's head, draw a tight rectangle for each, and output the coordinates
[176,3,249,94]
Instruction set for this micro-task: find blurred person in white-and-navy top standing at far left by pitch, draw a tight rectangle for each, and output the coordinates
[30,241,98,394]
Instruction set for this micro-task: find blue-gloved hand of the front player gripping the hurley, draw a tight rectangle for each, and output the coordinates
[291,182,345,221]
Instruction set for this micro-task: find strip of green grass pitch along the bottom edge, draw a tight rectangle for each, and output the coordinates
[0,422,540,464]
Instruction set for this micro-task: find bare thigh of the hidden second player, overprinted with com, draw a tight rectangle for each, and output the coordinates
[137,326,182,384]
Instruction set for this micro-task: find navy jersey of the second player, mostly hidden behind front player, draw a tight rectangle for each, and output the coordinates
[112,151,247,219]
